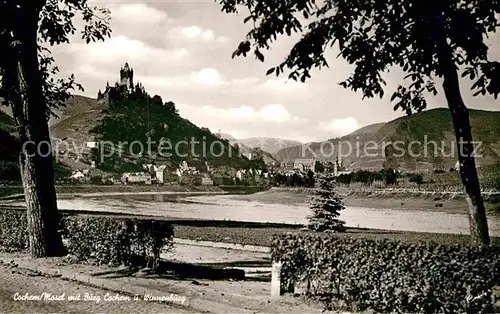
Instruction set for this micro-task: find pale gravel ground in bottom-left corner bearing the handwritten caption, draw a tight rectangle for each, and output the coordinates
[0,266,191,314]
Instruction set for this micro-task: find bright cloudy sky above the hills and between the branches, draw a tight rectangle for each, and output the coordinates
[53,0,500,142]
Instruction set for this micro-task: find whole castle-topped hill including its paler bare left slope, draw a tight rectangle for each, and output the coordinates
[0,65,263,177]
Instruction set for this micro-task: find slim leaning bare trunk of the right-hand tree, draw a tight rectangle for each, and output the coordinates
[439,45,490,245]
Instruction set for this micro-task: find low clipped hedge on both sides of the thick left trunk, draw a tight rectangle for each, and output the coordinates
[0,210,174,267]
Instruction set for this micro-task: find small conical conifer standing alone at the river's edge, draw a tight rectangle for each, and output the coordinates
[307,176,345,232]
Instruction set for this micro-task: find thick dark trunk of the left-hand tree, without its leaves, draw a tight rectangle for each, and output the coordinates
[2,4,66,258]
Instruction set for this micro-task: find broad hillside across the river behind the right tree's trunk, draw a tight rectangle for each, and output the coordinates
[277,108,500,170]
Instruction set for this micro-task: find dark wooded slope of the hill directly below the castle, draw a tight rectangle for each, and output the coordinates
[89,85,260,172]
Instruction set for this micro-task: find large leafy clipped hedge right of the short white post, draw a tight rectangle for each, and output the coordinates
[271,234,500,313]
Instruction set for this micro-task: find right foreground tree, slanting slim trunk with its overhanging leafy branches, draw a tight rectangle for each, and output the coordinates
[221,0,500,245]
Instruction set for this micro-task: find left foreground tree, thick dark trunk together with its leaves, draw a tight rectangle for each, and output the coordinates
[0,0,110,257]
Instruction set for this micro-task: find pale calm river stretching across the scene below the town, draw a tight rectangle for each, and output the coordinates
[3,191,500,236]
